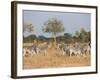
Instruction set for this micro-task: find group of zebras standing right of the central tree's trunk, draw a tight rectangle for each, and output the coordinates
[57,43,91,56]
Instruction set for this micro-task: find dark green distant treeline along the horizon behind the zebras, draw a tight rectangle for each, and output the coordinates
[23,30,91,43]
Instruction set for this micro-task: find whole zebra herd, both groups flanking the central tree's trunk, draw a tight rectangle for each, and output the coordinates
[23,42,91,56]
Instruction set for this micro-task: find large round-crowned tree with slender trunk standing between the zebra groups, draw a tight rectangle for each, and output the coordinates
[43,18,64,44]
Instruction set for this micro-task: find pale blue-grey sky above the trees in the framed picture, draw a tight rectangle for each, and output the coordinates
[23,10,91,37]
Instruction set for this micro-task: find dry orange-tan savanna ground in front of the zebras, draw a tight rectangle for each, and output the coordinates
[23,42,91,69]
